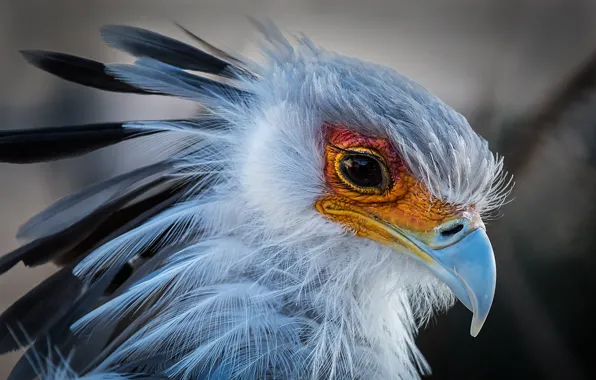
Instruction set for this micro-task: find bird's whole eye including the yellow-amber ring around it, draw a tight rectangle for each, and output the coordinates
[335,148,391,194]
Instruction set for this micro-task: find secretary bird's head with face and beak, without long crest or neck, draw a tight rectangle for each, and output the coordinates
[235,31,508,336]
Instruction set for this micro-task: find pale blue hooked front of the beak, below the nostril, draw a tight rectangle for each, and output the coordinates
[417,228,497,337]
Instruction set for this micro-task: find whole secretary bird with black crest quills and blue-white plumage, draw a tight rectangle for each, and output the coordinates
[0,19,512,380]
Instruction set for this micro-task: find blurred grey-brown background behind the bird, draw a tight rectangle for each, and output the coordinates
[0,0,596,379]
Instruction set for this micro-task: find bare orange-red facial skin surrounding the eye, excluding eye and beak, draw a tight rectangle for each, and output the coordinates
[316,123,473,252]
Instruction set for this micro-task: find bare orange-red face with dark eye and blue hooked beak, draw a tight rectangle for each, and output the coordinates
[315,125,496,336]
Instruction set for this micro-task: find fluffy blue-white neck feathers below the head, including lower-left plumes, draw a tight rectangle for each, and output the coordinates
[70,170,450,379]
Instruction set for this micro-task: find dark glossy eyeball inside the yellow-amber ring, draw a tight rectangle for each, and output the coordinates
[340,154,385,188]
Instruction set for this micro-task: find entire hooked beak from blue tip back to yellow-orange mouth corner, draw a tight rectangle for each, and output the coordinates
[317,200,497,337]
